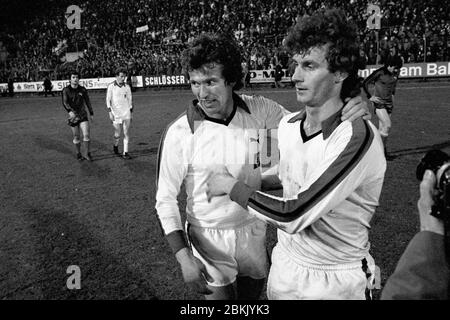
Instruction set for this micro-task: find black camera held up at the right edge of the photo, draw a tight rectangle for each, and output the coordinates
[416,150,450,220]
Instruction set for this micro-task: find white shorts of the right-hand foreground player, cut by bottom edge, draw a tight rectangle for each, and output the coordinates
[267,245,375,300]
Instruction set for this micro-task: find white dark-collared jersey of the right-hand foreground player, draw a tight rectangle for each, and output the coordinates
[230,111,386,264]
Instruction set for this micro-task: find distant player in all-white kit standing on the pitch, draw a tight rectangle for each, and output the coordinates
[106,68,133,159]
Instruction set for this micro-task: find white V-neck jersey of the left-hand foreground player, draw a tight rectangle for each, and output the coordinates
[156,94,288,234]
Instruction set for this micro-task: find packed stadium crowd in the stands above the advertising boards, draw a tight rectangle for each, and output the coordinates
[0,0,450,82]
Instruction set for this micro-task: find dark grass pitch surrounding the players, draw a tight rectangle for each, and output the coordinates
[0,82,450,299]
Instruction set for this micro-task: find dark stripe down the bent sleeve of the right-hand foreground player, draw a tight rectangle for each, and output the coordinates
[248,120,374,222]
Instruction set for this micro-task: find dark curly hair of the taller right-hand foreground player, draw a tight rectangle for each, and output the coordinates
[285,8,361,100]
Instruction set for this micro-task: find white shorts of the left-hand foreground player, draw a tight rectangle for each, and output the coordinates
[187,220,268,287]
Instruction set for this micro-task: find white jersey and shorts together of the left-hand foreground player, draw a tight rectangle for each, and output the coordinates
[156,90,287,298]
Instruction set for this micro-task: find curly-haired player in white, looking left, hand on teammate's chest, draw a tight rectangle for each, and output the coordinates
[208,9,386,299]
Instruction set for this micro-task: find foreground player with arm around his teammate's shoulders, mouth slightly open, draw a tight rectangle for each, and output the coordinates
[156,35,365,299]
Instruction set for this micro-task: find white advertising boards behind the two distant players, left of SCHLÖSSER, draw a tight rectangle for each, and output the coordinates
[0,76,143,93]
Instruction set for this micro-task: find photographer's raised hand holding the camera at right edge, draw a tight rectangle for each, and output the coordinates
[417,170,444,235]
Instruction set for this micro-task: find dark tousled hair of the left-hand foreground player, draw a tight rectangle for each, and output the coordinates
[181,33,243,90]
